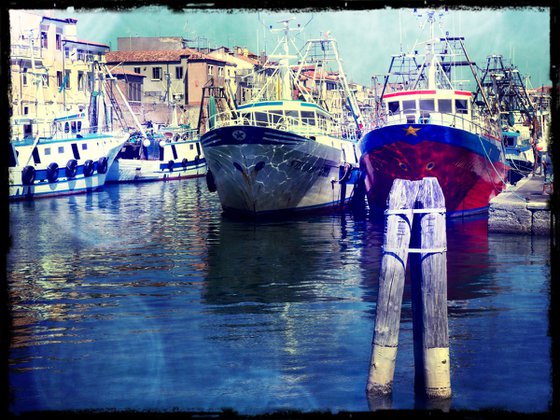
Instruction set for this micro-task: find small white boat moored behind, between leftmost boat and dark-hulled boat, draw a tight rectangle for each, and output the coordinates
[107,101,206,182]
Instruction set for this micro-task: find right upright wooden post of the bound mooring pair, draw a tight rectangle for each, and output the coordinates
[410,178,451,399]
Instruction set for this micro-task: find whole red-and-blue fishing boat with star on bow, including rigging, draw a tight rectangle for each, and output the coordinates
[360,11,508,216]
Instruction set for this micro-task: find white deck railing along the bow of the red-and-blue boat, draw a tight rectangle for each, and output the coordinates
[370,109,502,141]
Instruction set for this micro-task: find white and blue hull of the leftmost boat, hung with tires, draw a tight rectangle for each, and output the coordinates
[9,136,127,201]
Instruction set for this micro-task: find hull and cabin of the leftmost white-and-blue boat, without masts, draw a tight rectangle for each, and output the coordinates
[8,111,128,200]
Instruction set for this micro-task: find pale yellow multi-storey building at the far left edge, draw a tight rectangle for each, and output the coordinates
[9,10,109,135]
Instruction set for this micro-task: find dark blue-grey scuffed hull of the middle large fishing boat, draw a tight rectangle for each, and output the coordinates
[202,126,357,216]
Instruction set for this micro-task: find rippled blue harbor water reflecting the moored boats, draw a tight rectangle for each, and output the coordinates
[7,179,552,414]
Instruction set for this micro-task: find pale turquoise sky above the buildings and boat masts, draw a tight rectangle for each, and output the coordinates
[43,6,551,88]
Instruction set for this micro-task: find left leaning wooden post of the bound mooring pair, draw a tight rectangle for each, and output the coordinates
[366,179,419,395]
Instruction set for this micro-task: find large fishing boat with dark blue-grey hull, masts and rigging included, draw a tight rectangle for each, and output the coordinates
[201,20,360,217]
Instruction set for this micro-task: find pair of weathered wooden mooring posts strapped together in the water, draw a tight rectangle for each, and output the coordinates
[366,178,451,399]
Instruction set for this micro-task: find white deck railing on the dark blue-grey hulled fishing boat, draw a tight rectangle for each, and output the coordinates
[206,111,358,140]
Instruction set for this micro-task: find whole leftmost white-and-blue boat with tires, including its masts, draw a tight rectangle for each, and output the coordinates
[8,46,129,201]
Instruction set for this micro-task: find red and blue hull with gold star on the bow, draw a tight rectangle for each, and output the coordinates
[360,124,508,216]
